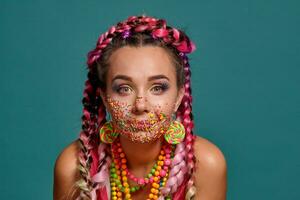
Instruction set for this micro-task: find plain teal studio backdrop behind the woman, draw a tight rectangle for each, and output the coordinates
[0,0,300,200]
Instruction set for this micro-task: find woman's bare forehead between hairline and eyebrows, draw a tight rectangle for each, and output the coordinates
[107,46,176,80]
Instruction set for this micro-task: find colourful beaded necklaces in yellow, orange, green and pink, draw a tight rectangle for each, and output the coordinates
[110,140,175,200]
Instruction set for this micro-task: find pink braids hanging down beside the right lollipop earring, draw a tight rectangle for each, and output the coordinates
[162,55,195,199]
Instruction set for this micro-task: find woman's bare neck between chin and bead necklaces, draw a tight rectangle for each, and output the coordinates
[120,136,163,173]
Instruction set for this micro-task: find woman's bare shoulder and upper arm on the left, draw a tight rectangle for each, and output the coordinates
[53,140,80,200]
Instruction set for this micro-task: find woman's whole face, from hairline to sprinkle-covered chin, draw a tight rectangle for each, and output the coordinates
[102,46,184,143]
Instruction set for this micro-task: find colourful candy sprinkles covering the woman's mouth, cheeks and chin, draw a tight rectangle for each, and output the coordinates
[107,97,171,143]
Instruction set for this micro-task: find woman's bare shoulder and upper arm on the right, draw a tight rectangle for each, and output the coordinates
[194,136,227,200]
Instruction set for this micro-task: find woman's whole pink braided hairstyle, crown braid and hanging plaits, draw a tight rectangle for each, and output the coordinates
[77,16,195,199]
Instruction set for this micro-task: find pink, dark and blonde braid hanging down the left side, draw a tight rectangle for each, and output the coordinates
[77,77,105,199]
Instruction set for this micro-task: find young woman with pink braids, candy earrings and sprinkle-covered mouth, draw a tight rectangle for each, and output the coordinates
[54,16,226,200]
